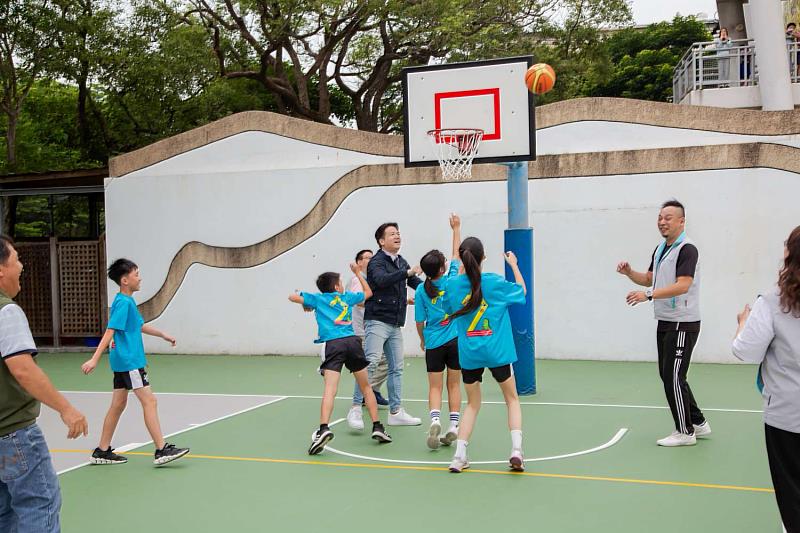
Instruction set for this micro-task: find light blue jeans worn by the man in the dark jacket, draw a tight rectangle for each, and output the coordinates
[353,320,403,413]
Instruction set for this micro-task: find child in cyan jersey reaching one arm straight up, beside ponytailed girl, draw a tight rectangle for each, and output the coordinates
[414,215,461,450]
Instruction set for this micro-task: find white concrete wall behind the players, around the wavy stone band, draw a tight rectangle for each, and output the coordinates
[106,129,800,362]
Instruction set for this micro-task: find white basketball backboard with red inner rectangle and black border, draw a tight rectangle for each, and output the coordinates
[403,56,536,167]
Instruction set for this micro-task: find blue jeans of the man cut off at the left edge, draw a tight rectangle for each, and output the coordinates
[0,424,61,533]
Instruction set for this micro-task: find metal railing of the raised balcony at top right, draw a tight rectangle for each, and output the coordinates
[672,39,760,103]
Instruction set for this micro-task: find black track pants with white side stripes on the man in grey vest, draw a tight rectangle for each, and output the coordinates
[656,331,705,434]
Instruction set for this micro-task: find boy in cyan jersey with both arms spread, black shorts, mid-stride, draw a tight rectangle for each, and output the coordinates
[289,263,392,455]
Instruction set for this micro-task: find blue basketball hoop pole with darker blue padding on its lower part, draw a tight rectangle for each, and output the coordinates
[503,161,536,394]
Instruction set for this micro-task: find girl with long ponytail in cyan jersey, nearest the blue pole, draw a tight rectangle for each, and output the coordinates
[444,237,526,473]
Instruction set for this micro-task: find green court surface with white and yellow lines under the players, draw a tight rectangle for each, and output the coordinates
[39,354,779,533]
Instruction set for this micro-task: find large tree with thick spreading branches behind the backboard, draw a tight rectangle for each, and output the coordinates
[177,0,629,132]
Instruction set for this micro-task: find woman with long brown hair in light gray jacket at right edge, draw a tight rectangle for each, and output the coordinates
[733,226,800,533]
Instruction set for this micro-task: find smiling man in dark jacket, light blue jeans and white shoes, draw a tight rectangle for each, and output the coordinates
[347,222,422,429]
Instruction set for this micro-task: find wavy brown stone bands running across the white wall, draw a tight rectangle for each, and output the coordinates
[109,98,800,321]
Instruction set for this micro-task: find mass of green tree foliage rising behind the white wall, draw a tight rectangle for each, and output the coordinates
[0,0,710,172]
